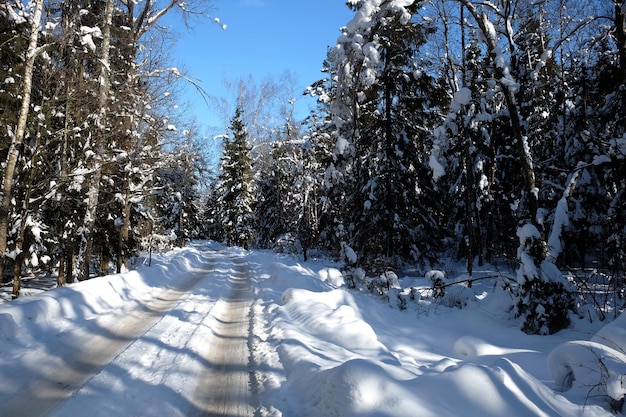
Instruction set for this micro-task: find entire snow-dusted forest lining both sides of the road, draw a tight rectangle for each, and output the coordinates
[0,0,626,334]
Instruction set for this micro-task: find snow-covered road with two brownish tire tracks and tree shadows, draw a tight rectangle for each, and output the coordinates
[0,249,254,417]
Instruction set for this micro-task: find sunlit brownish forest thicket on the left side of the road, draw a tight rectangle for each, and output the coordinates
[0,0,210,297]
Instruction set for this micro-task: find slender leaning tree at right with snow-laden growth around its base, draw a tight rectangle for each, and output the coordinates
[454,0,574,334]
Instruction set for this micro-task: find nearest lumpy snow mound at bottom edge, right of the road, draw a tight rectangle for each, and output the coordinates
[289,352,578,417]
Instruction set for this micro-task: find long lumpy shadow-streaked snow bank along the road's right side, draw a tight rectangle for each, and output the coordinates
[260,264,608,417]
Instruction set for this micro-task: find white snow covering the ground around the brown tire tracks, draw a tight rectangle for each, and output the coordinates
[0,242,626,417]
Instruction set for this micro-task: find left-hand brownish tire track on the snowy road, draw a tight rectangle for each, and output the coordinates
[0,273,212,417]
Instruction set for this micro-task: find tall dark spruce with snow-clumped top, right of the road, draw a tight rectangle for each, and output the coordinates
[328,1,439,268]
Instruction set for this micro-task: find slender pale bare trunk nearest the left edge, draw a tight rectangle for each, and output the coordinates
[0,0,43,278]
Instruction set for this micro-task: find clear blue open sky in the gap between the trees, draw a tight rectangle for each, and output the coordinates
[168,0,353,132]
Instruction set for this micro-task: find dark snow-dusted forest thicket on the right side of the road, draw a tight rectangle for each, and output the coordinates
[206,0,626,333]
